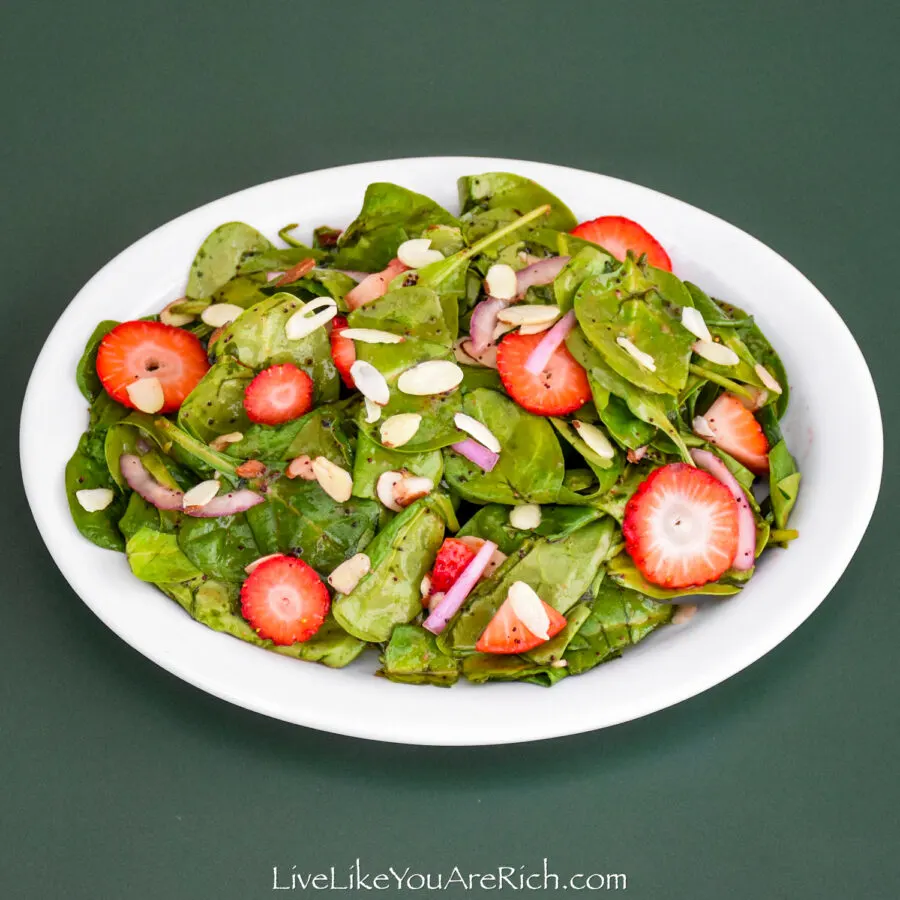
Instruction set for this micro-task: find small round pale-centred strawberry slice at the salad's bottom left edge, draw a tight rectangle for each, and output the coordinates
[241,555,331,646]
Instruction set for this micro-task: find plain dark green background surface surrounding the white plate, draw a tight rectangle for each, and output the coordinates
[0,0,900,900]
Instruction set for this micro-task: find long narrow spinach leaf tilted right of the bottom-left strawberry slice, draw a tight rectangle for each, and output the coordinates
[332,500,444,641]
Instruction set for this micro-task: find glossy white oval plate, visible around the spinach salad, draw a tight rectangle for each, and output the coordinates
[21,157,882,745]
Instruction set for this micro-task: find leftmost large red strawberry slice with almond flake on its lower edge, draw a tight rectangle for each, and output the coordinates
[97,322,209,413]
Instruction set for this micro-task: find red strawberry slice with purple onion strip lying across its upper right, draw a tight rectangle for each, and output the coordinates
[497,332,591,416]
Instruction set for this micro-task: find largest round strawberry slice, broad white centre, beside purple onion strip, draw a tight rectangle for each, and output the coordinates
[622,463,738,588]
